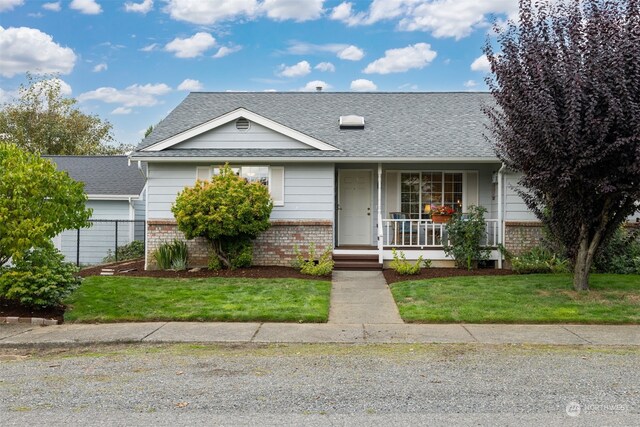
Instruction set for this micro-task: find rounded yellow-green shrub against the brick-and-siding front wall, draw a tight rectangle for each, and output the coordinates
[171,165,273,268]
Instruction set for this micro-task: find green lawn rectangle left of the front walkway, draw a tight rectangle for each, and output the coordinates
[64,276,331,322]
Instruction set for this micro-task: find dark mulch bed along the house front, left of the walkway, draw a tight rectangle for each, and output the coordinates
[79,260,331,280]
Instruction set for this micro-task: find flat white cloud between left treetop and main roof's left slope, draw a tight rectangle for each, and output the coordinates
[78,83,171,107]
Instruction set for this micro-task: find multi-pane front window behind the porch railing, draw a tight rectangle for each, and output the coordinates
[400,171,463,219]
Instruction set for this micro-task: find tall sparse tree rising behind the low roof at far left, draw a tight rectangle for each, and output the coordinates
[0,74,131,155]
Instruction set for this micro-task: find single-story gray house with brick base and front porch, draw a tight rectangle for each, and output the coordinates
[130,92,540,265]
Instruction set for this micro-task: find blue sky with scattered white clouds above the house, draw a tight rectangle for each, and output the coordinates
[0,0,517,144]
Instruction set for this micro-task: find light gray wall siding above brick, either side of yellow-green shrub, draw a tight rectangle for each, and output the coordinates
[147,163,334,220]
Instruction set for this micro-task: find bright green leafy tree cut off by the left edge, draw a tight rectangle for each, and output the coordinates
[0,142,91,266]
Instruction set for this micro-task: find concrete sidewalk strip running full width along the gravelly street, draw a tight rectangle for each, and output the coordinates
[0,322,640,347]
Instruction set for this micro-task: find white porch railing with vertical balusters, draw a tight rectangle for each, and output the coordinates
[382,219,499,248]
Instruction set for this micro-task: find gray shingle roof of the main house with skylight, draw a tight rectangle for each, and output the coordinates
[132,92,496,160]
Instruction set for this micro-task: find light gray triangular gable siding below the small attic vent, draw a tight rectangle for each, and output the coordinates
[173,120,313,149]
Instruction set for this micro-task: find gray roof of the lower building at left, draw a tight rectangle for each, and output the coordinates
[42,156,145,196]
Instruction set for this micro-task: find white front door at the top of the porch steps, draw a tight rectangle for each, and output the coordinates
[338,170,371,246]
